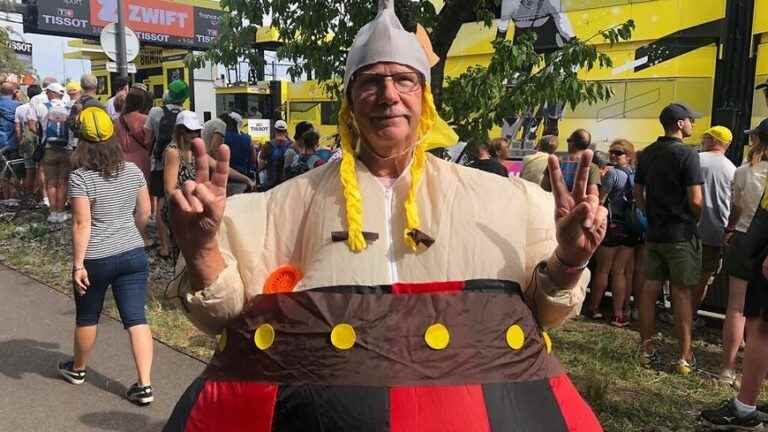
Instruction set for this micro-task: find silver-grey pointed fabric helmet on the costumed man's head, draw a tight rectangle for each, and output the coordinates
[344,0,430,89]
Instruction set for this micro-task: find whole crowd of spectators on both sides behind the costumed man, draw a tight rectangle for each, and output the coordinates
[0,70,768,426]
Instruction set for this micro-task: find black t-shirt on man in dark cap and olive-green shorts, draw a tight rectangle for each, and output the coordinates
[635,137,704,243]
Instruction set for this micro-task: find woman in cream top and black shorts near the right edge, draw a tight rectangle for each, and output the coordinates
[720,134,768,385]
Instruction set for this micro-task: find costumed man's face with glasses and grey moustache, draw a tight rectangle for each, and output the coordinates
[351,63,423,157]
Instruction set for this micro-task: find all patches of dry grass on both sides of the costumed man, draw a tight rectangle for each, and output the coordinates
[0,206,760,432]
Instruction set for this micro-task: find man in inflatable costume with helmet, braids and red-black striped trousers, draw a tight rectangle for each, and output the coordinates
[165,0,607,432]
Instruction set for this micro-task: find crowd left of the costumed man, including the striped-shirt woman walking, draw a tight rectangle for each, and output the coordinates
[0,74,340,405]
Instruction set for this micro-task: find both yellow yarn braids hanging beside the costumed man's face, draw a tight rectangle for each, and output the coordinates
[339,84,438,252]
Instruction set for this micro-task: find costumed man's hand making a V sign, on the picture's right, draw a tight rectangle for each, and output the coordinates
[548,150,608,267]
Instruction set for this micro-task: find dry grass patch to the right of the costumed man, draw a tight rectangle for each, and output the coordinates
[551,321,733,432]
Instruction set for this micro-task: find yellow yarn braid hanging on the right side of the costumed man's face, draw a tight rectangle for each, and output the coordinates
[404,84,437,252]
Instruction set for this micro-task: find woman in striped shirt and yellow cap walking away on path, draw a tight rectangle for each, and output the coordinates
[59,107,153,405]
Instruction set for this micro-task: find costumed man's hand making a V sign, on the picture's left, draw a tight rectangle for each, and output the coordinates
[170,138,229,262]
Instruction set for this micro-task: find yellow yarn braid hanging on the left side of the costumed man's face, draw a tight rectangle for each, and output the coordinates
[339,98,368,252]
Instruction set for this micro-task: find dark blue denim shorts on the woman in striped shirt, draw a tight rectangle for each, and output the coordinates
[75,248,149,329]
